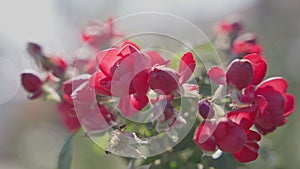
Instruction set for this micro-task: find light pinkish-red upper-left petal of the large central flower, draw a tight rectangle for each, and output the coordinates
[96,48,121,76]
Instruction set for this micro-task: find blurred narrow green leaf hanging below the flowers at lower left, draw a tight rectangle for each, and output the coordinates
[57,134,74,169]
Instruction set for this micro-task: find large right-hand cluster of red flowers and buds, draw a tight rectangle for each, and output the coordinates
[193,18,295,162]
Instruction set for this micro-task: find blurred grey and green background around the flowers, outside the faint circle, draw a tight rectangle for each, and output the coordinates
[0,0,300,169]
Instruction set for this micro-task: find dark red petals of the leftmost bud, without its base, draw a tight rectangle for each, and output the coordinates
[21,73,42,92]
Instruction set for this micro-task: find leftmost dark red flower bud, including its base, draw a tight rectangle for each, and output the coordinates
[21,73,43,99]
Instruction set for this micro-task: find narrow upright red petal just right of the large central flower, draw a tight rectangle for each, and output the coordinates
[178,52,196,84]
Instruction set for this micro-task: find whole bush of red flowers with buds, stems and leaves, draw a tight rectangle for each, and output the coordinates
[21,15,295,168]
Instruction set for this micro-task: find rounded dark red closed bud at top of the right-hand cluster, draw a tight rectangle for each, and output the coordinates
[226,59,253,90]
